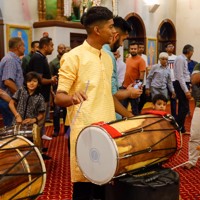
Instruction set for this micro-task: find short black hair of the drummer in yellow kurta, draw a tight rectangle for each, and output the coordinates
[81,6,113,30]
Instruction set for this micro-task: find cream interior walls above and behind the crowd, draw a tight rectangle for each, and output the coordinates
[0,0,200,61]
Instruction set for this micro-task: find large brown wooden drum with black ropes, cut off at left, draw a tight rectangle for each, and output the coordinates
[0,135,46,200]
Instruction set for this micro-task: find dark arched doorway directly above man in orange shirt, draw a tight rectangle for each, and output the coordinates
[124,13,146,56]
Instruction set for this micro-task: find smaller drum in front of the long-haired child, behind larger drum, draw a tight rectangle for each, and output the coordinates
[0,124,42,149]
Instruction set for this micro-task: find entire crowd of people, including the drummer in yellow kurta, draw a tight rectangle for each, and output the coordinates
[0,6,200,200]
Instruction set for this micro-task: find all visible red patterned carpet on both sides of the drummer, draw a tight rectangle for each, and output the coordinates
[38,101,200,200]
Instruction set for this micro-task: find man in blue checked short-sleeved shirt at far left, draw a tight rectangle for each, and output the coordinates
[0,37,25,126]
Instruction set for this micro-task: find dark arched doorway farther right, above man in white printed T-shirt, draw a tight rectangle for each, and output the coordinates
[157,19,176,54]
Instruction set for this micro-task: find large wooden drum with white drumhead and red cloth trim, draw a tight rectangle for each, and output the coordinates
[76,112,181,185]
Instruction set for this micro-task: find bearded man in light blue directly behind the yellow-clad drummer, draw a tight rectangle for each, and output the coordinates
[103,16,141,119]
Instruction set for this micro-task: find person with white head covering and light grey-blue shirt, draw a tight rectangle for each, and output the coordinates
[146,52,176,98]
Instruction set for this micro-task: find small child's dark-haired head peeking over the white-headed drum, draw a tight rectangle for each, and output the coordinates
[152,94,168,111]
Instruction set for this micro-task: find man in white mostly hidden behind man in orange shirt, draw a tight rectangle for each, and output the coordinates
[138,42,148,113]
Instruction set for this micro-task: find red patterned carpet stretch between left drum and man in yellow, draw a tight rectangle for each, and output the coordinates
[38,126,72,200]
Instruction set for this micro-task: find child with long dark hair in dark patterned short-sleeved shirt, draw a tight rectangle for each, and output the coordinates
[9,72,45,125]
